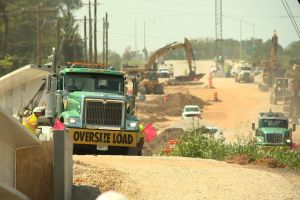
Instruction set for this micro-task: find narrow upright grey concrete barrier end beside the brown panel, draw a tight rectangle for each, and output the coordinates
[53,130,73,200]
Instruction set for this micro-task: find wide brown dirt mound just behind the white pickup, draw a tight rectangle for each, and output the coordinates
[139,93,209,116]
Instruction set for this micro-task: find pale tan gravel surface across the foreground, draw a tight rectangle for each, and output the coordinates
[73,156,300,200]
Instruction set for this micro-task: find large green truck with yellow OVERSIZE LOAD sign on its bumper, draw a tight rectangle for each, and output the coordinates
[21,60,142,155]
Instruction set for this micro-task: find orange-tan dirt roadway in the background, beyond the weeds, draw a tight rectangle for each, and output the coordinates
[165,60,300,143]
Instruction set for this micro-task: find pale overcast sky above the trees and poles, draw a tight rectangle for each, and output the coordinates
[75,0,300,54]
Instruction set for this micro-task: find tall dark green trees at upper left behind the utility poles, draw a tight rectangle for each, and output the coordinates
[0,0,83,75]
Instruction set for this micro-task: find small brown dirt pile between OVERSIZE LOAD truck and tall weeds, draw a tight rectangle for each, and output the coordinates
[143,128,183,156]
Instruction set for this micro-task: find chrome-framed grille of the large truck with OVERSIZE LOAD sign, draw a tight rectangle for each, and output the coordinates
[85,99,124,127]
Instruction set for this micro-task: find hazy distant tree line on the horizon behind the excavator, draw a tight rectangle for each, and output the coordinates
[122,38,300,68]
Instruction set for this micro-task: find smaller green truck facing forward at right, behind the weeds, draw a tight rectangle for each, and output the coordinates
[252,110,296,148]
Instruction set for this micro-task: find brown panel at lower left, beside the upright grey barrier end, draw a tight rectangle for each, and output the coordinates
[16,142,53,200]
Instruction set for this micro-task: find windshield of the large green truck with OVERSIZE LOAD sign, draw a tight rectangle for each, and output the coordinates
[65,73,124,94]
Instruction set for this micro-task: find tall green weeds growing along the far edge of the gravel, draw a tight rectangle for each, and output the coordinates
[171,127,300,168]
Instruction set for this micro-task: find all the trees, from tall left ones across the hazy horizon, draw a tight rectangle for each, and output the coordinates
[0,0,300,76]
